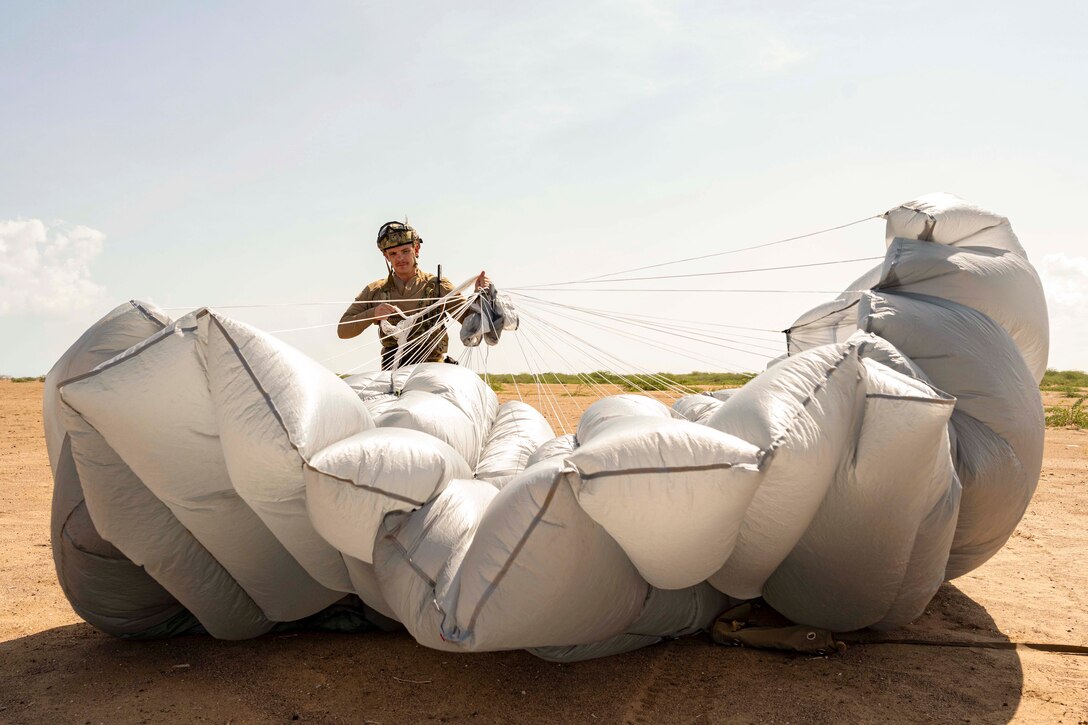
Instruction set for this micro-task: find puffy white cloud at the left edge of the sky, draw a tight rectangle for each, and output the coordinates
[0,219,106,315]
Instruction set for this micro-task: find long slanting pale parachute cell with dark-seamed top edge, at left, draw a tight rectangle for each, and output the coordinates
[61,311,342,626]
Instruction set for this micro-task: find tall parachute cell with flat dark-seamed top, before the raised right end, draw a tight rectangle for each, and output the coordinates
[764,352,959,631]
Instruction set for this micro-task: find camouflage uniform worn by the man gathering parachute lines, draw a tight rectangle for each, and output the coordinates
[341,268,465,369]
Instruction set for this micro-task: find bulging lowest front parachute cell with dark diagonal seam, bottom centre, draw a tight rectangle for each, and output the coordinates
[437,458,647,651]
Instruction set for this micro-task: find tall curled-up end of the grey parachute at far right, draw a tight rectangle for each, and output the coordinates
[788,189,1049,578]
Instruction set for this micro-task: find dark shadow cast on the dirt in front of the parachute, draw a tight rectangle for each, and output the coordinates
[0,585,1023,724]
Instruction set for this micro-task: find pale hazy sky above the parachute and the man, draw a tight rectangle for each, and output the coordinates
[0,0,1088,374]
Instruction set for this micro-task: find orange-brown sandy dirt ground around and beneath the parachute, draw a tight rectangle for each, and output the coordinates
[0,382,1088,725]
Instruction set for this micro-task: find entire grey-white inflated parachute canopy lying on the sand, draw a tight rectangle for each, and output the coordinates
[45,194,1048,661]
